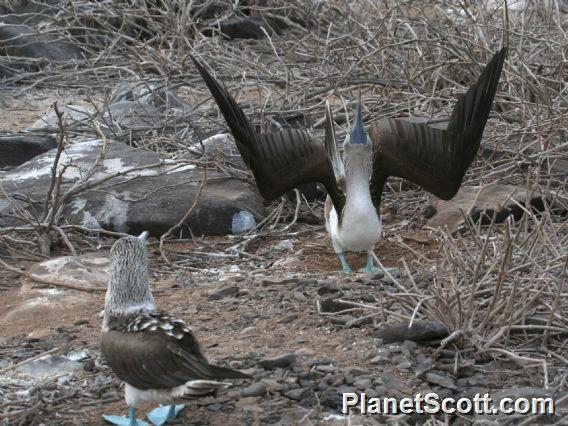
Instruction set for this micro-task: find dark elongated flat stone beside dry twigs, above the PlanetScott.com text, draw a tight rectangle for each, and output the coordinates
[376,320,450,343]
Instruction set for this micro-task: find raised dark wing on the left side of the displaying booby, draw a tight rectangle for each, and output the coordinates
[192,57,345,212]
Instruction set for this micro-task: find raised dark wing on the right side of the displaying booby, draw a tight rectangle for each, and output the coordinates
[369,47,507,208]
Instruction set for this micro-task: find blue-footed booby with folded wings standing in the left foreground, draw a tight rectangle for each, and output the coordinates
[100,232,250,426]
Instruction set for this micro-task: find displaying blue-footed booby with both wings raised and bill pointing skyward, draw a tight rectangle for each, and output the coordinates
[192,47,507,272]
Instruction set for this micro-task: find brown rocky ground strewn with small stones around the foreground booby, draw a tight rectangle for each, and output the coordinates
[0,228,566,424]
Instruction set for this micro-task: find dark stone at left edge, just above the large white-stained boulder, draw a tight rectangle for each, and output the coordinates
[0,133,57,168]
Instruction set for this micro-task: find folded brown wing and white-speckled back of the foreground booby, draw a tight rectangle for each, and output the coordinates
[100,312,250,391]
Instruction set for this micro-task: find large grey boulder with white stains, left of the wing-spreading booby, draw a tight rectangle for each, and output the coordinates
[0,139,264,236]
